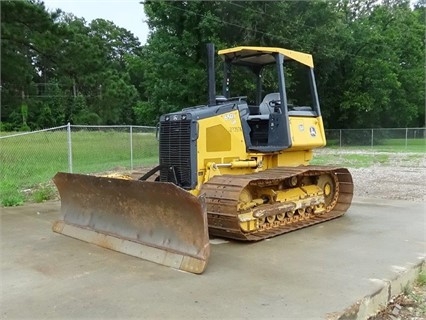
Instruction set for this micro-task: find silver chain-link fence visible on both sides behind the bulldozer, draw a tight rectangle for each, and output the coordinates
[0,124,426,205]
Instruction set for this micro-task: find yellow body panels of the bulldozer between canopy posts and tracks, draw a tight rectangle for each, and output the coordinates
[191,105,325,199]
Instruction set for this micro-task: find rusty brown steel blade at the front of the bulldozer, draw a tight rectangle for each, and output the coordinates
[53,172,210,273]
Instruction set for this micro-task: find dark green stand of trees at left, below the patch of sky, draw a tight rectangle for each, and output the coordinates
[1,0,141,129]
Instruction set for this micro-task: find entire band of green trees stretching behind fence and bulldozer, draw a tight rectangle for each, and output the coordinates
[0,0,426,129]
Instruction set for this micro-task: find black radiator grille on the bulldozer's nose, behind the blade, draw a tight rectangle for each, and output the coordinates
[160,120,192,189]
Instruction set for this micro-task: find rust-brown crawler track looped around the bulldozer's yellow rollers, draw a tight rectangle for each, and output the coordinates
[201,166,353,241]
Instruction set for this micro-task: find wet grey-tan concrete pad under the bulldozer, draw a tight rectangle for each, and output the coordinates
[0,198,426,319]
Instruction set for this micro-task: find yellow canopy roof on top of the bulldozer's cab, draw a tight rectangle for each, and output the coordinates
[218,47,314,68]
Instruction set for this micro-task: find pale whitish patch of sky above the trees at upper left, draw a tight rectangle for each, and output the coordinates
[43,0,148,44]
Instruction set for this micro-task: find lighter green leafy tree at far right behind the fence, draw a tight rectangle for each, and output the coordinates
[334,1,425,128]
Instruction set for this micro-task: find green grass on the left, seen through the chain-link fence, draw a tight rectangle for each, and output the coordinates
[0,131,158,206]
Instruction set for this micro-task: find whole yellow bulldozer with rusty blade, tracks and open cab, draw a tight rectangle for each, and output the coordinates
[53,45,353,274]
